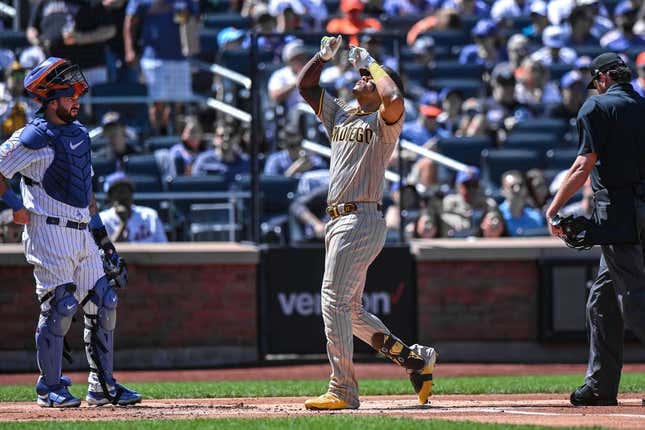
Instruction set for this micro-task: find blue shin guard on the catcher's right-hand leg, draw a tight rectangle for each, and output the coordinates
[83,277,121,404]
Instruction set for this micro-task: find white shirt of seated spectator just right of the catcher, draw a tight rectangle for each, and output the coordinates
[99,205,168,243]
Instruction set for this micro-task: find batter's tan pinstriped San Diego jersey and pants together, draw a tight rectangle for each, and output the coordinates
[318,89,405,406]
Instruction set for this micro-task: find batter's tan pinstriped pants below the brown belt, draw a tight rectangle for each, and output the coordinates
[321,203,390,406]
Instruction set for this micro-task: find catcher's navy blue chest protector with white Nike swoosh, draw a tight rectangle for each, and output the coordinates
[20,118,92,208]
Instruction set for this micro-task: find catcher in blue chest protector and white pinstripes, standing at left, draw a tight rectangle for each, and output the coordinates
[0,57,141,408]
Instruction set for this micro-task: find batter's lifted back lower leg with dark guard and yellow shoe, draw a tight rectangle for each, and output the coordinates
[370,333,437,405]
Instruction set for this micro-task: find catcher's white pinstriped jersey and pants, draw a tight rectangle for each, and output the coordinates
[0,129,105,302]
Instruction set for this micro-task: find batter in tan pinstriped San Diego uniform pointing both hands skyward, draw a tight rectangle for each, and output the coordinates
[298,36,436,409]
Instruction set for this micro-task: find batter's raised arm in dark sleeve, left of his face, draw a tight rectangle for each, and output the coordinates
[298,36,343,115]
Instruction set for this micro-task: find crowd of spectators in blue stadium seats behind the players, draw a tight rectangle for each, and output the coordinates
[0,0,645,242]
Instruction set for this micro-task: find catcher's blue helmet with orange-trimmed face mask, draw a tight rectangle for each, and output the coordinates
[24,57,88,104]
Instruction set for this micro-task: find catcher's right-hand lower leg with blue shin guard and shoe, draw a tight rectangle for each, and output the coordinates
[84,276,141,406]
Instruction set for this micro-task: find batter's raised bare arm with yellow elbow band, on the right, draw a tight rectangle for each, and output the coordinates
[349,46,404,124]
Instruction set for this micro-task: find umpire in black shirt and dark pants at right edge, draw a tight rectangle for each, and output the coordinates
[546,52,645,406]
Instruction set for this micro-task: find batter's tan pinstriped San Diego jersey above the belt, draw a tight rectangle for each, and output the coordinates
[319,92,405,204]
